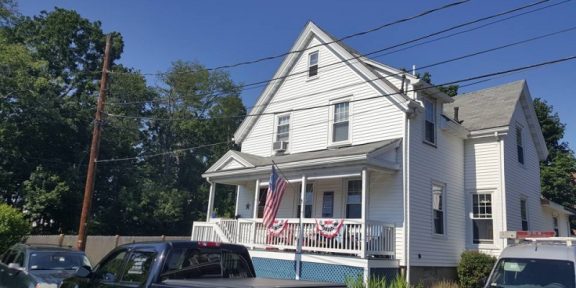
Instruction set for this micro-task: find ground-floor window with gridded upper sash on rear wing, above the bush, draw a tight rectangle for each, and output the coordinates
[472,194,494,244]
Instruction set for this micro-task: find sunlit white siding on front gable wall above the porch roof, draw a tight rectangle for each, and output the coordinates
[242,38,404,157]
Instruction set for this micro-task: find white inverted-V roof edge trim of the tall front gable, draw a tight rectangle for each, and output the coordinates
[234,21,409,144]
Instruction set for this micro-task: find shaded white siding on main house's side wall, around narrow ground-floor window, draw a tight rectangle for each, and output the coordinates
[409,107,466,267]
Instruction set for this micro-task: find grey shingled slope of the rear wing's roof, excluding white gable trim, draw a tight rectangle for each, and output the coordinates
[444,80,525,131]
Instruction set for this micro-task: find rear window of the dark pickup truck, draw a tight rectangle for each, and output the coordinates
[160,248,254,280]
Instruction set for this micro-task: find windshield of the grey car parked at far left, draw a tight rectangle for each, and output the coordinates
[28,251,90,270]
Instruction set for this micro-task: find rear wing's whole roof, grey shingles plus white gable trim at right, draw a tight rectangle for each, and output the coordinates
[444,80,548,160]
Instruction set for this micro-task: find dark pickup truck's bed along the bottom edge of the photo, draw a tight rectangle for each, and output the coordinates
[153,278,346,288]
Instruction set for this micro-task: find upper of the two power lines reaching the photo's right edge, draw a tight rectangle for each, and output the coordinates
[107,26,576,121]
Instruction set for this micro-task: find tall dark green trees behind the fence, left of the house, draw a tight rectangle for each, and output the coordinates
[0,7,246,235]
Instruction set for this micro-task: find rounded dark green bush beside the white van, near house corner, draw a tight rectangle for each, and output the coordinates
[458,251,496,288]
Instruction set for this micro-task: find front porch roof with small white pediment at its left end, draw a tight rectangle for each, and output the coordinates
[202,139,402,177]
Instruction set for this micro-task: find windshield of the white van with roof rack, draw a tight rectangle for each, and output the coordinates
[488,258,576,288]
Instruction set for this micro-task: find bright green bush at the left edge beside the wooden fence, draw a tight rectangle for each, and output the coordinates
[0,203,30,253]
